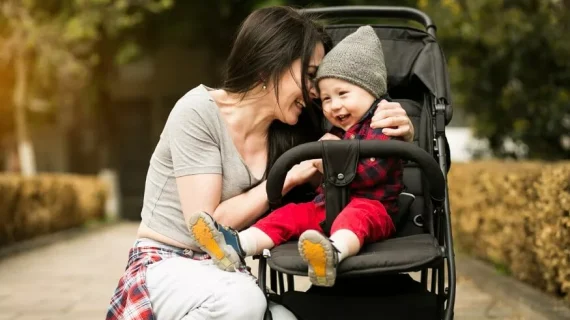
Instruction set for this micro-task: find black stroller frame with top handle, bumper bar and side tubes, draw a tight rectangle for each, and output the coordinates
[254,6,456,320]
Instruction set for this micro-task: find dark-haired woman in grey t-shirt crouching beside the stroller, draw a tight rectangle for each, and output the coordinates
[107,7,413,320]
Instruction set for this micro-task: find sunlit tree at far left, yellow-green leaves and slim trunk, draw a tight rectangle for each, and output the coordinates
[0,0,172,175]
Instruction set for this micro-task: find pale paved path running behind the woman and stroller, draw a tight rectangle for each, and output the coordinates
[0,223,535,320]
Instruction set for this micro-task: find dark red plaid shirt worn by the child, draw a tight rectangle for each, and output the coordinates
[314,104,404,215]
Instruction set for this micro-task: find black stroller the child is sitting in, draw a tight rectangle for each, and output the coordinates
[257,6,455,320]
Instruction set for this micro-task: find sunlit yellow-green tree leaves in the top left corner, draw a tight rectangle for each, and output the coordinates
[0,0,173,114]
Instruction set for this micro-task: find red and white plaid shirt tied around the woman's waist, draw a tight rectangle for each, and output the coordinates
[106,240,210,320]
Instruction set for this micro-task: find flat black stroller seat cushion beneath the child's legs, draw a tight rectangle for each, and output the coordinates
[267,234,443,278]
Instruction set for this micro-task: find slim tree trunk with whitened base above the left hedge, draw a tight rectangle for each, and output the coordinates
[13,52,36,176]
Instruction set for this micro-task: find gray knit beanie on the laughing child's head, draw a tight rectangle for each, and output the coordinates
[315,26,387,99]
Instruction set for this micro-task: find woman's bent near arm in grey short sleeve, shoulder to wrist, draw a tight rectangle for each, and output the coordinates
[163,96,267,228]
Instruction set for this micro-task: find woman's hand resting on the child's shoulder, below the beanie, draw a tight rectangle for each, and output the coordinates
[370,100,414,142]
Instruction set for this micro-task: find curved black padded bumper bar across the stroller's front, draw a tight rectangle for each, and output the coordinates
[266,140,446,206]
